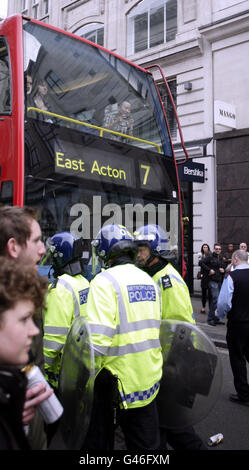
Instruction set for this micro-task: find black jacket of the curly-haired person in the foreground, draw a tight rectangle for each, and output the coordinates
[0,366,30,450]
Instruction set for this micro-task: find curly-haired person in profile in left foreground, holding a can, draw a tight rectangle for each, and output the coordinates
[0,257,49,450]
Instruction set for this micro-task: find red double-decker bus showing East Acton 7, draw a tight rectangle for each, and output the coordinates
[0,15,187,276]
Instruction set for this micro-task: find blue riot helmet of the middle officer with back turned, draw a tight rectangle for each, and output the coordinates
[92,224,137,265]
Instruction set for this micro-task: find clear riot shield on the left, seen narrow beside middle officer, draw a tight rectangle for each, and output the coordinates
[59,317,94,450]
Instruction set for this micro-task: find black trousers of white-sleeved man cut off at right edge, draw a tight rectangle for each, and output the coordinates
[226,322,249,401]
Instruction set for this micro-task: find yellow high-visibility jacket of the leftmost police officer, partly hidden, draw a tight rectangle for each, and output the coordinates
[43,274,89,387]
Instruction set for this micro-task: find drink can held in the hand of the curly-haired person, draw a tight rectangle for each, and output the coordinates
[24,365,63,424]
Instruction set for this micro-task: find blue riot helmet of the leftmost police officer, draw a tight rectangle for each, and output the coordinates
[46,232,89,276]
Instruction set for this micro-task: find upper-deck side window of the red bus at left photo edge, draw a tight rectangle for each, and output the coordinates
[0,37,11,114]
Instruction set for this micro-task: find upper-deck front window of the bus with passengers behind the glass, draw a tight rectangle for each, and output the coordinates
[23,21,173,158]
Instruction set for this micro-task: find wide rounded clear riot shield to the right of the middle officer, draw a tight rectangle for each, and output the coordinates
[157,320,222,429]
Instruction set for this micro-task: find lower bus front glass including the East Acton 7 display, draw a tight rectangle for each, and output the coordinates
[25,119,181,280]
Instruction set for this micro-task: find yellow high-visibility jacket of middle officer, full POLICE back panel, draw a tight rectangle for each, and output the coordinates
[87,263,162,408]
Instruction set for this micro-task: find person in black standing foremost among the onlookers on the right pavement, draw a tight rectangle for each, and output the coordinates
[199,243,225,326]
